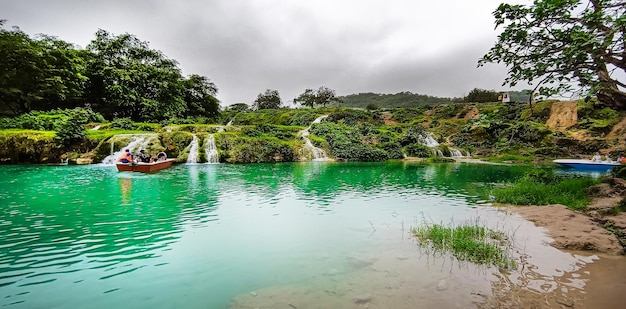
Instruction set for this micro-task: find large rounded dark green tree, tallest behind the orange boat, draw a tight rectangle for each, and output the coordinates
[87,30,186,121]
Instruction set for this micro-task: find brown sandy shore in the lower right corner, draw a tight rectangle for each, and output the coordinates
[505,199,626,309]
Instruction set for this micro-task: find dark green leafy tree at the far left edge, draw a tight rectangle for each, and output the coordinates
[0,23,86,114]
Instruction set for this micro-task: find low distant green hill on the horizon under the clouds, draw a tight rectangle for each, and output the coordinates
[333,91,456,108]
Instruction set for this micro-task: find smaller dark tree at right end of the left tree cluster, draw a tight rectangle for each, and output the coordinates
[185,74,220,117]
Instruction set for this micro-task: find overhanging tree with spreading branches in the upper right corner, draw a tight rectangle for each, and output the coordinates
[478,0,626,110]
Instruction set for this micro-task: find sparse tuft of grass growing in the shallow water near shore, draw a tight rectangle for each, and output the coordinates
[411,221,517,268]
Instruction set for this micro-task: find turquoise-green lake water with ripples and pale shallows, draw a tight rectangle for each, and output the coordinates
[0,162,596,308]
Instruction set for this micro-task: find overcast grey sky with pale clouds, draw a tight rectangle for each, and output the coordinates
[0,0,530,105]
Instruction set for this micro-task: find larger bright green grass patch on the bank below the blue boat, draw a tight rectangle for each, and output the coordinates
[491,170,600,210]
